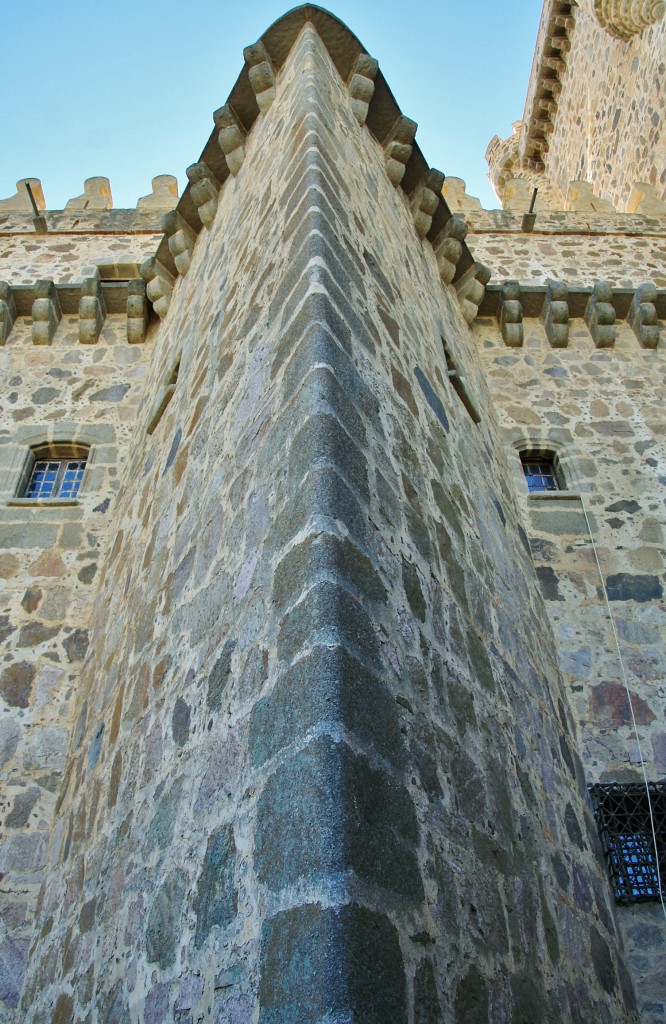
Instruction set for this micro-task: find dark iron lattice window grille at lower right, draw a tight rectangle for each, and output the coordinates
[589,782,666,903]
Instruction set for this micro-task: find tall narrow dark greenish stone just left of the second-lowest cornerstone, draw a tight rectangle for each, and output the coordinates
[194,825,238,949]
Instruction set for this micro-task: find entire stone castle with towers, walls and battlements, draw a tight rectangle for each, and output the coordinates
[0,0,666,1024]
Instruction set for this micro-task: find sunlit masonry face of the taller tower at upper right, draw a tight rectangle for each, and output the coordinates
[545,6,666,210]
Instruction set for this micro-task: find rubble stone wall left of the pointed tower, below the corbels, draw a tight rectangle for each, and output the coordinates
[0,305,150,1021]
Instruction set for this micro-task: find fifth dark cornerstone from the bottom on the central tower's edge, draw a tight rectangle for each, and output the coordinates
[273,534,386,608]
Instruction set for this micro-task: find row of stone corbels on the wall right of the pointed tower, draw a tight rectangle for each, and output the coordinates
[485,279,666,348]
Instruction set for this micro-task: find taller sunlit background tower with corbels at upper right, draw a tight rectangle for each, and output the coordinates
[486,0,666,213]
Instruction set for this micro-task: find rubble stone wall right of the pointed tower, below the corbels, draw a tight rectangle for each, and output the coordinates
[474,313,666,1024]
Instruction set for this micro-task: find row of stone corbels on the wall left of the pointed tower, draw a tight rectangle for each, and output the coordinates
[0,268,150,345]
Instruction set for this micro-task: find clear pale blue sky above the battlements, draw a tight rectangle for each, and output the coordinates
[0,0,541,209]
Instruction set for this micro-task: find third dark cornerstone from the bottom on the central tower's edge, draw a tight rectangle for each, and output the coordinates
[250,647,405,767]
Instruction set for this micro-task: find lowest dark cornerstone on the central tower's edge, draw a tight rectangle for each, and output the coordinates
[259,905,407,1024]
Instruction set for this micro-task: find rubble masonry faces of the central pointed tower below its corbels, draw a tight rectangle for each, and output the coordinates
[15,26,635,1024]
